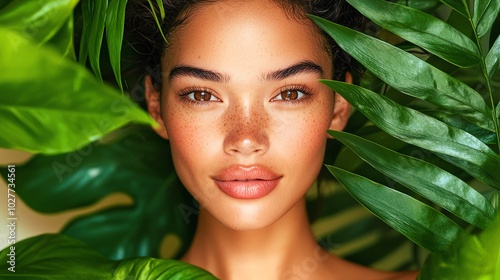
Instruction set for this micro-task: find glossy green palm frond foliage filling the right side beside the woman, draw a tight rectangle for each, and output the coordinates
[310,0,500,279]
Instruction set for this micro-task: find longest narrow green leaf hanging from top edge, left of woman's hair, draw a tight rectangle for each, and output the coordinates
[106,0,127,91]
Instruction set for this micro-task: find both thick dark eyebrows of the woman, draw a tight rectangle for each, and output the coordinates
[168,60,323,83]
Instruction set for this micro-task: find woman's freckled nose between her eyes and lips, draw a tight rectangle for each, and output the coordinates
[224,102,269,156]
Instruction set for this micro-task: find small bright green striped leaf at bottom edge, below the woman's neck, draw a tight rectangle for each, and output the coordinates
[113,258,217,280]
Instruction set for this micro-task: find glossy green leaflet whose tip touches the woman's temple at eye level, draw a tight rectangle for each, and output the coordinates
[321,80,500,187]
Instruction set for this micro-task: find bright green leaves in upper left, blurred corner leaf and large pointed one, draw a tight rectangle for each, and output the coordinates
[0,1,153,154]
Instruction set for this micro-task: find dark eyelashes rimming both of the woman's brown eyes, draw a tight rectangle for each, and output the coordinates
[177,85,313,105]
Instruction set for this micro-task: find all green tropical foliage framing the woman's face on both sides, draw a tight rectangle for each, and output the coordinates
[0,0,500,279]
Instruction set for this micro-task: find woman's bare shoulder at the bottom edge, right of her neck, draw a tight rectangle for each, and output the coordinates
[330,256,419,280]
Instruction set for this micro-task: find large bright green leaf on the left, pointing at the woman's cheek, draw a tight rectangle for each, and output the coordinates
[0,28,153,154]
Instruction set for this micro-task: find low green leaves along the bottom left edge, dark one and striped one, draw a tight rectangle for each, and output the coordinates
[0,234,216,280]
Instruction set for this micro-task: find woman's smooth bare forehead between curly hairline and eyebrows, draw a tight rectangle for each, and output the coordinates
[162,0,332,76]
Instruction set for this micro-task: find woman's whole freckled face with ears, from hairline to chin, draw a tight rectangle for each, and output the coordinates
[147,1,348,230]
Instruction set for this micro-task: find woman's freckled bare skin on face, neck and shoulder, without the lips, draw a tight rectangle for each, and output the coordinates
[146,1,416,279]
